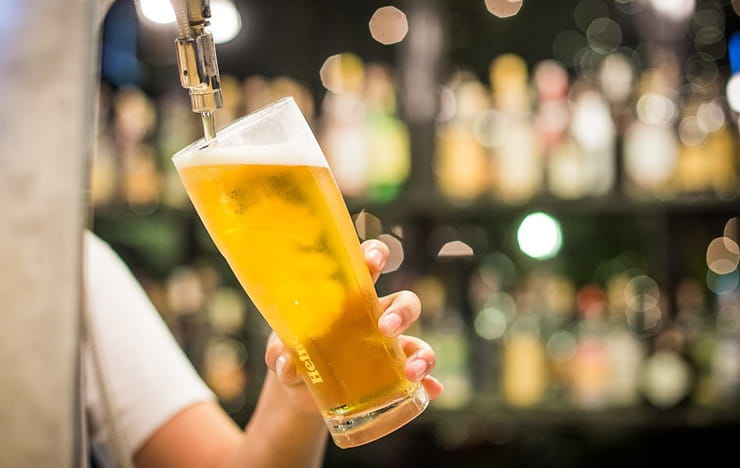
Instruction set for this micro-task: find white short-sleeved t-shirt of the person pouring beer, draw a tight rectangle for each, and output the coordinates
[82,231,216,464]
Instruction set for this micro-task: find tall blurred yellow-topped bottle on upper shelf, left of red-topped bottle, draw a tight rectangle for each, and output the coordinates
[488,54,544,203]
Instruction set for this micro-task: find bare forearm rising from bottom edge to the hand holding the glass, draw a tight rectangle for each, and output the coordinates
[224,371,328,468]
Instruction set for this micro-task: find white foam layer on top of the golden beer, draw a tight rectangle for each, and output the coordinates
[173,143,329,169]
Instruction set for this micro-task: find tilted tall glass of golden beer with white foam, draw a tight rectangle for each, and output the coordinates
[172,97,429,448]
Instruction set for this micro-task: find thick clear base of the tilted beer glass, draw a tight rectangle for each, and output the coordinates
[324,385,429,448]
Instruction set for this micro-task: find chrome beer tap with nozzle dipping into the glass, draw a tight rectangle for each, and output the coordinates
[170,0,223,143]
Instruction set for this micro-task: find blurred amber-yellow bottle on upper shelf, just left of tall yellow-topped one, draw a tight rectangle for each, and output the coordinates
[434,71,490,204]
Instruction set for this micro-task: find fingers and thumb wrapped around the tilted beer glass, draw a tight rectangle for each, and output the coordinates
[265,240,443,412]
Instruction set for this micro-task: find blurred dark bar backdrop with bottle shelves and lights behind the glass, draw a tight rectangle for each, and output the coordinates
[90,0,740,468]
